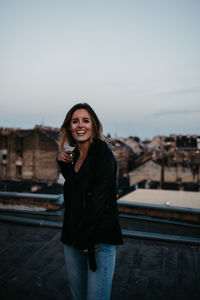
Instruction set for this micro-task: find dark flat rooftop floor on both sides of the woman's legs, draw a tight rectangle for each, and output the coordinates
[0,222,200,300]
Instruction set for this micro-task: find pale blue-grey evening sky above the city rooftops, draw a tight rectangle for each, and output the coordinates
[0,0,200,138]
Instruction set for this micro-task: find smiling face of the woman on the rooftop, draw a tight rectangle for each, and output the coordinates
[70,108,92,143]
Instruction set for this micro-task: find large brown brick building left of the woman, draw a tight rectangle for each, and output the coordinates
[0,126,58,182]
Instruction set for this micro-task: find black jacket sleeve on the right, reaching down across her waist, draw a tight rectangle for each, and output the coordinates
[75,144,117,249]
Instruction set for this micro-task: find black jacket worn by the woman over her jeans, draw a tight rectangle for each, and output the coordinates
[57,138,123,249]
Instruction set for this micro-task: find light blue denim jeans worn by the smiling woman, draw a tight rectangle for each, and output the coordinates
[64,244,116,300]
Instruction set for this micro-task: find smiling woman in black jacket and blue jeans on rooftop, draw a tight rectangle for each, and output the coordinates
[57,103,123,300]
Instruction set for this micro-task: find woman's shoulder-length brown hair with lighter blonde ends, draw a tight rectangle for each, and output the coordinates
[59,103,104,151]
